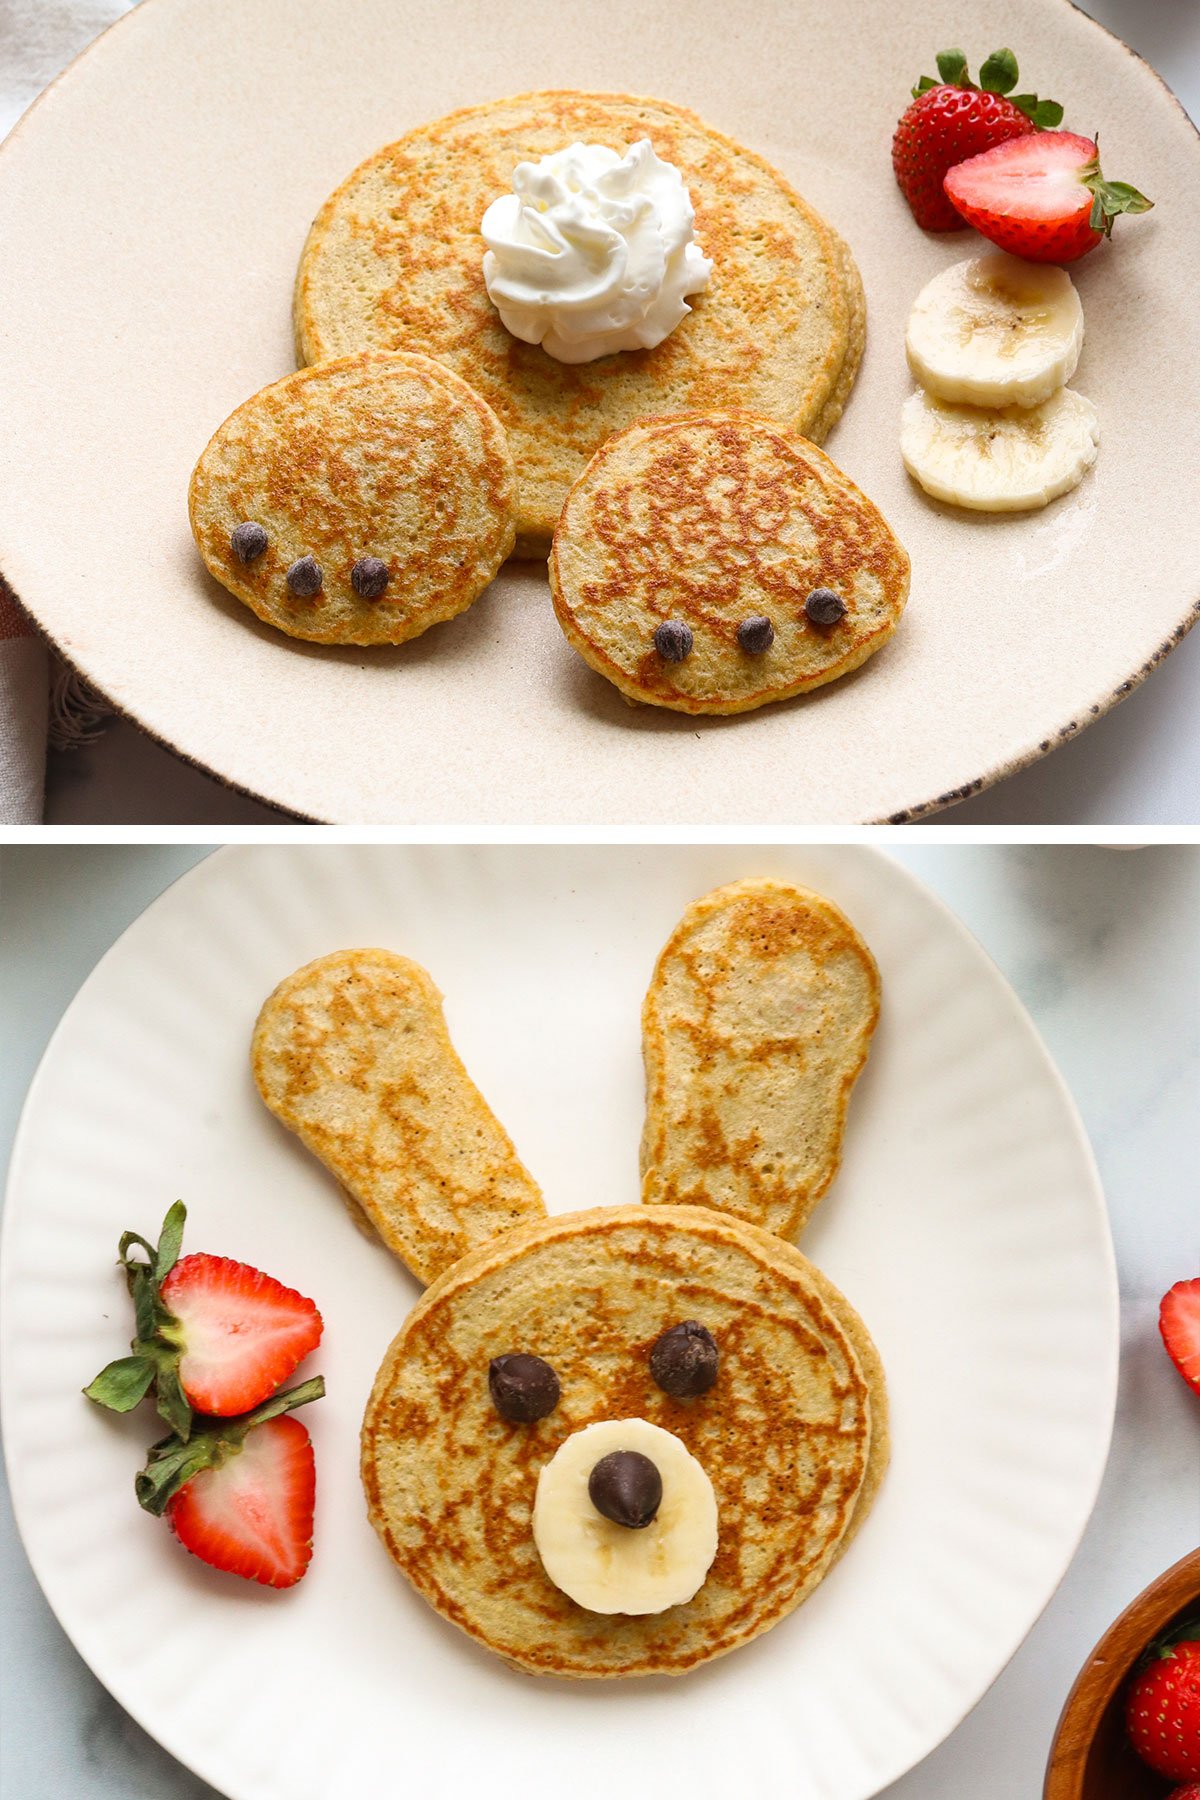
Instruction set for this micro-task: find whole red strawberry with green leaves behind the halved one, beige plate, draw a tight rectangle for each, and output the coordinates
[892,50,1063,230]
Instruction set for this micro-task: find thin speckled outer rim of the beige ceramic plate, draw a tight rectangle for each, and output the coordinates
[0,0,1200,824]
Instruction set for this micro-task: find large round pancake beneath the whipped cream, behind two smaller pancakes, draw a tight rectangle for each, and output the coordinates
[295,92,865,554]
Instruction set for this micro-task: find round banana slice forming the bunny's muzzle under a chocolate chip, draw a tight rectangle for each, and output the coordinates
[533,1418,716,1613]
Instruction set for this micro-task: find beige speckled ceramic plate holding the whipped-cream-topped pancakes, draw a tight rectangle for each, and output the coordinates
[0,0,1200,824]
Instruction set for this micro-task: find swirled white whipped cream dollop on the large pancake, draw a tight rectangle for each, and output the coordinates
[480,139,712,362]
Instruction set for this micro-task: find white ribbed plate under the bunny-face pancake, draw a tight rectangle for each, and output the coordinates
[0,846,1117,1800]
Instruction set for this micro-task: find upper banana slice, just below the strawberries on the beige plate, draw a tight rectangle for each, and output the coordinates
[905,250,1083,407]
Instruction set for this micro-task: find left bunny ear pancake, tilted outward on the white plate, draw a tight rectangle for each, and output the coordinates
[250,950,545,1282]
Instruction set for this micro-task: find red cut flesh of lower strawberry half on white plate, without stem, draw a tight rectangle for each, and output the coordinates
[167,1417,317,1588]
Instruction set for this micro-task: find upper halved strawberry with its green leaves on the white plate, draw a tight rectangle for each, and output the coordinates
[83,1201,322,1442]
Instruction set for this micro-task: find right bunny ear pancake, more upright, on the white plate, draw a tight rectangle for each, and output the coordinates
[642,880,880,1238]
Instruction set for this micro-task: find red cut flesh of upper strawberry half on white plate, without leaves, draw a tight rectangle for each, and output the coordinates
[160,1253,322,1418]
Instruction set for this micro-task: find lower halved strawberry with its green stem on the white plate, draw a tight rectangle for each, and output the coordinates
[137,1375,326,1588]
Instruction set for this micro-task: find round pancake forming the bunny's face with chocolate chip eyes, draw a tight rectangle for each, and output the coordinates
[362,1206,887,1678]
